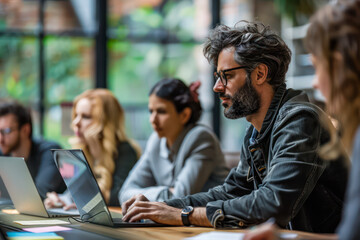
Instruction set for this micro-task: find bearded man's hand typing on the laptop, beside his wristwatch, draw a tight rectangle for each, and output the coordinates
[123,200,183,225]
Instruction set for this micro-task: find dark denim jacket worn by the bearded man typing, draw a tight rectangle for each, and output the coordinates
[166,84,348,233]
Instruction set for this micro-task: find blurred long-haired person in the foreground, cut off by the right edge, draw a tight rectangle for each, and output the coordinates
[244,0,360,240]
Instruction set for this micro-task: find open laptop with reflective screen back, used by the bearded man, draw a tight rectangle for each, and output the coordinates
[51,149,168,227]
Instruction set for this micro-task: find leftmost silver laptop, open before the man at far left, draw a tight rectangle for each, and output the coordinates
[0,157,79,217]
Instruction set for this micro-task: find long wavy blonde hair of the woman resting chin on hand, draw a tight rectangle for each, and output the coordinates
[69,89,140,198]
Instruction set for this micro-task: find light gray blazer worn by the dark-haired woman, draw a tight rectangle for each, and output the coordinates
[119,124,229,204]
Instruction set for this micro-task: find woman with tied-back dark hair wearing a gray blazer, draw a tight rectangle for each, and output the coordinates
[119,78,228,203]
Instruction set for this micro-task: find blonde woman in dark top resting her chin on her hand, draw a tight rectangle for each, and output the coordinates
[45,89,140,209]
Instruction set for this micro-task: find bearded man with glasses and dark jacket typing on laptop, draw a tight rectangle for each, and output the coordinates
[122,22,348,233]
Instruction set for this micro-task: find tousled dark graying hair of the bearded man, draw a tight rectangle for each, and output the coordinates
[204,21,291,89]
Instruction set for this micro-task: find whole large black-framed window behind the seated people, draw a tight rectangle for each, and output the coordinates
[0,0,327,151]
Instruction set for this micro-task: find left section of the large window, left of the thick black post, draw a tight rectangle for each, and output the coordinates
[0,0,95,147]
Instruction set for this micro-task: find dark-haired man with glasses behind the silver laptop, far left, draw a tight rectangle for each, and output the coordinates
[0,99,66,198]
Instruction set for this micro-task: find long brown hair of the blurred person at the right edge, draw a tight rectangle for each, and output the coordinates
[305,0,360,152]
